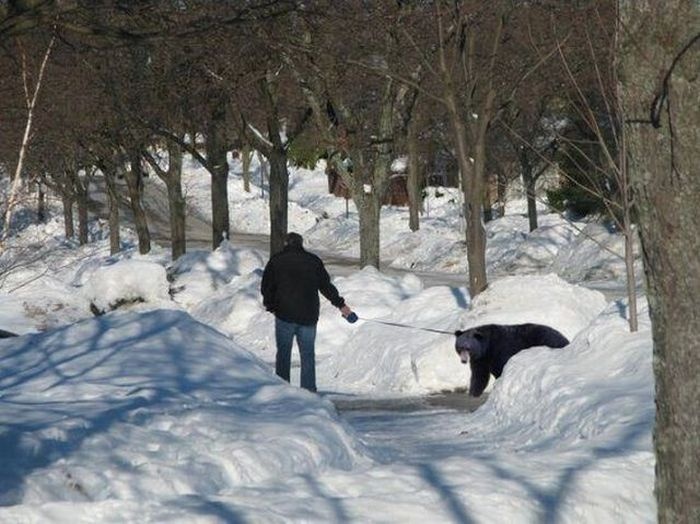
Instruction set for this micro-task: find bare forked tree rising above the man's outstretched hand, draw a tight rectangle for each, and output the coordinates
[281,2,424,268]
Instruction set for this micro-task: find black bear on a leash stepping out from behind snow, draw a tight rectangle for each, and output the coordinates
[455,324,569,397]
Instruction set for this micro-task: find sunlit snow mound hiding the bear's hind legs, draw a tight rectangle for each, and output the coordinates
[476,298,654,449]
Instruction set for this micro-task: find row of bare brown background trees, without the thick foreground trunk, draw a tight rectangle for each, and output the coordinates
[0,0,612,295]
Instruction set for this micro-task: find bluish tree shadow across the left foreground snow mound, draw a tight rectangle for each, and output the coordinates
[0,311,252,506]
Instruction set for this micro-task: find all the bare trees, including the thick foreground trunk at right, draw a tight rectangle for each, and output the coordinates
[0,0,700,522]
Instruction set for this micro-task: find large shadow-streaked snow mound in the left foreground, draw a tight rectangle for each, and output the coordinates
[0,310,366,522]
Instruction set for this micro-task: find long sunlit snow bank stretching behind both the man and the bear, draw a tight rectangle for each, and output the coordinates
[186,250,606,396]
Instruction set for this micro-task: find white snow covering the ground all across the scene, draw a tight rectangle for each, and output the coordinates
[0,151,655,523]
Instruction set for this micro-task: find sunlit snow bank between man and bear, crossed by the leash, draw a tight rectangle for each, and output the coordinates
[319,270,468,396]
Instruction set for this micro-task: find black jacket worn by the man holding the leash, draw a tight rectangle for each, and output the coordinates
[261,246,345,326]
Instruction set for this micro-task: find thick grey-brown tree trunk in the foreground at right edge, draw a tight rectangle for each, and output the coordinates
[619,0,700,524]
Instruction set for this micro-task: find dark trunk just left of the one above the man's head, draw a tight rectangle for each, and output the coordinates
[206,102,230,249]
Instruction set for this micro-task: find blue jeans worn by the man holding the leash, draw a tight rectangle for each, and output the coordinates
[275,317,316,391]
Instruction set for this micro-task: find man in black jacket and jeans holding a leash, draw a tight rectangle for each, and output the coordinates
[261,233,357,391]
